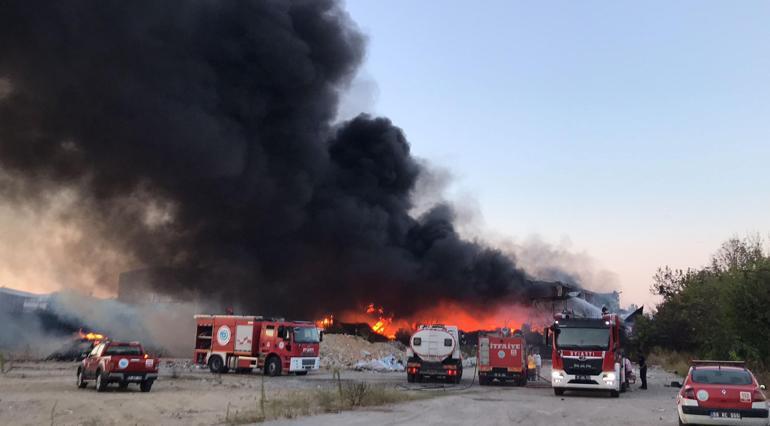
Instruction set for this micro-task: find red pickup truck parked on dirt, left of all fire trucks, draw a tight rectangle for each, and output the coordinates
[77,341,159,392]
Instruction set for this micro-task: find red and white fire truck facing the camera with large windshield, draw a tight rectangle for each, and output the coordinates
[546,314,626,397]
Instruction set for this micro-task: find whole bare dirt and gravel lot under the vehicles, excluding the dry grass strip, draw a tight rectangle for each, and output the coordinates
[0,362,676,426]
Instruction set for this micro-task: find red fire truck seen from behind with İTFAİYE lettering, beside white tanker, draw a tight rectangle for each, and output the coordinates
[476,328,527,386]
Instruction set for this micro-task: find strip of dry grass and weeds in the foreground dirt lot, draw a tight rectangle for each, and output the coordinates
[225,382,431,425]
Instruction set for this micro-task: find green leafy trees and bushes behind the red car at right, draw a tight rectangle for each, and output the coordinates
[635,237,770,384]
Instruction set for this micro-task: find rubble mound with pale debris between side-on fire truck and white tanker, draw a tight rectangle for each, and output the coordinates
[321,334,406,371]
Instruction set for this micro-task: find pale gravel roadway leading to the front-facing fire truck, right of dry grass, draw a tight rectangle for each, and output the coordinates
[270,366,677,426]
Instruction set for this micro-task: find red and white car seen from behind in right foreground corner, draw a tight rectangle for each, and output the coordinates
[676,361,770,426]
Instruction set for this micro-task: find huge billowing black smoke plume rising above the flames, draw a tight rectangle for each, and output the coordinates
[0,0,530,315]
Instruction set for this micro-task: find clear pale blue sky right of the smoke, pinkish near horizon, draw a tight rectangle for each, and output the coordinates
[346,0,770,304]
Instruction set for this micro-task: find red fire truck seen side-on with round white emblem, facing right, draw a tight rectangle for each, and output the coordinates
[193,315,322,376]
